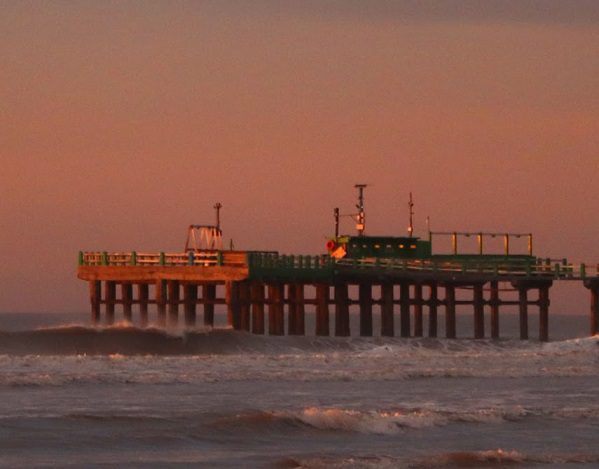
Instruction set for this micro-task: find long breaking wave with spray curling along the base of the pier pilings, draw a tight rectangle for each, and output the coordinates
[0,322,599,356]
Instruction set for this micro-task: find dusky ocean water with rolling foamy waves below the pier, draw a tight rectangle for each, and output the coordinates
[0,313,599,468]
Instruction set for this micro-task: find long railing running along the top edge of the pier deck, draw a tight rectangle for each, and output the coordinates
[79,251,599,280]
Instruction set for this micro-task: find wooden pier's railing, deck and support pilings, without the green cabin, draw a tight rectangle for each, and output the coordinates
[78,250,599,341]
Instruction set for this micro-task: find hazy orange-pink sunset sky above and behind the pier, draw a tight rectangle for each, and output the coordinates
[0,0,599,312]
